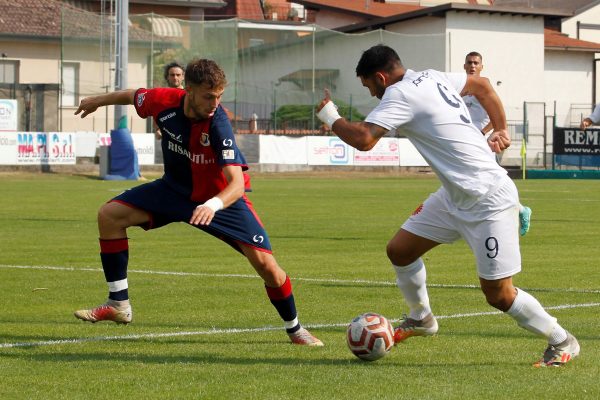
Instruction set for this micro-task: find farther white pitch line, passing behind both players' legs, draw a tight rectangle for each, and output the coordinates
[0,264,600,294]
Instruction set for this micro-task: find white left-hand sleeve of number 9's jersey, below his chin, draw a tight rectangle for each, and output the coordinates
[365,86,413,131]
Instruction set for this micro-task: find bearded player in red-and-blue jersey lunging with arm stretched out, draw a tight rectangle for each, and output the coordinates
[75,59,323,346]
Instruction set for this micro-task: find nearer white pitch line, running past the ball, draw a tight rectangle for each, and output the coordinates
[0,303,600,349]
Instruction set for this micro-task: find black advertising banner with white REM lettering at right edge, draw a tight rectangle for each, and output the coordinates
[553,128,600,156]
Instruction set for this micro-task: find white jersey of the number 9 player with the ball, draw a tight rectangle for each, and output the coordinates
[365,69,507,209]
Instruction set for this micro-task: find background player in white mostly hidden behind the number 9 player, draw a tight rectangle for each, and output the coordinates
[463,51,531,236]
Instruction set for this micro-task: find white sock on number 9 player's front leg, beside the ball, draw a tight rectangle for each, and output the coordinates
[393,258,431,321]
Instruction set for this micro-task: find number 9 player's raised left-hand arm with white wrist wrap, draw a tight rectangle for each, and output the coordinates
[317,89,387,151]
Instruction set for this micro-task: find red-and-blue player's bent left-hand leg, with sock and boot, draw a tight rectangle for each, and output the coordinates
[74,202,149,324]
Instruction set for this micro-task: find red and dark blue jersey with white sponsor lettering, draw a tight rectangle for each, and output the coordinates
[134,88,248,202]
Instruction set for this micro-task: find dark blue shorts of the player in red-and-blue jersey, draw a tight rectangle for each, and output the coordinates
[111,179,271,253]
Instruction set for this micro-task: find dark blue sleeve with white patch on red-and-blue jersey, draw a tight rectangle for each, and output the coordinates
[210,106,248,171]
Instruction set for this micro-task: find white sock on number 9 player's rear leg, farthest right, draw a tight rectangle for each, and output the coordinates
[506,289,567,345]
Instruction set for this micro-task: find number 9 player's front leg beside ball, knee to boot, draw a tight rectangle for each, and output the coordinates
[387,229,439,343]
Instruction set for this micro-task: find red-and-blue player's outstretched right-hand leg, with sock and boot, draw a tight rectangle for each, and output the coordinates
[241,246,323,346]
